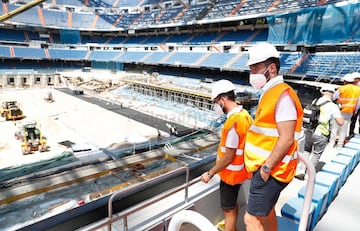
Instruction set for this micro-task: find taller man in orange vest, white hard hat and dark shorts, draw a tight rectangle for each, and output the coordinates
[244,42,303,231]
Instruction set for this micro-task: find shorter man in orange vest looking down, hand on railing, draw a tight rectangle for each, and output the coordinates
[201,80,253,231]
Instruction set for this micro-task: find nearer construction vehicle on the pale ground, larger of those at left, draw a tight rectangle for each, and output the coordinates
[15,121,49,155]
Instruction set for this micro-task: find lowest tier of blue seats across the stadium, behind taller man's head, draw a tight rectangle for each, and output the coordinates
[0,42,360,82]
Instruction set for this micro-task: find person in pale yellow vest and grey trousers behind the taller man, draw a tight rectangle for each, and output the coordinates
[295,85,344,180]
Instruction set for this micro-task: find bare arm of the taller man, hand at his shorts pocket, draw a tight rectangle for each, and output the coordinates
[261,120,296,181]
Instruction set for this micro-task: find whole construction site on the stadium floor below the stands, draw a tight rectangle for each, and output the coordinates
[0,69,258,230]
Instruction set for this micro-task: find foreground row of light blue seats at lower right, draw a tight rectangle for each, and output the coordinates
[278,135,360,230]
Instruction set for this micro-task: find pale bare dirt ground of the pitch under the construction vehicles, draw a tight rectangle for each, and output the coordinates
[0,88,162,169]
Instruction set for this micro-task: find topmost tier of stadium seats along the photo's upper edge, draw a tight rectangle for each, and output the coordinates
[0,0,341,30]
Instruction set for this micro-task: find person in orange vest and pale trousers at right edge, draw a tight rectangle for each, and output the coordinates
[330,73,360,148]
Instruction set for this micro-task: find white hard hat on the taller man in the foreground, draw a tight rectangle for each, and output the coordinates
[246,42,280,66]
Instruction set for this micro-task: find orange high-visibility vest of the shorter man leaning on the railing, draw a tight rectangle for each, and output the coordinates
[217,109,253,185]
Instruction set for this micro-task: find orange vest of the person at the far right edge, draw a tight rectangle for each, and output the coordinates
[337,84,360,113]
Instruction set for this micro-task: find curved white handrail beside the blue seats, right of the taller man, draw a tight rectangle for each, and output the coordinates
[298,153,316,231]
